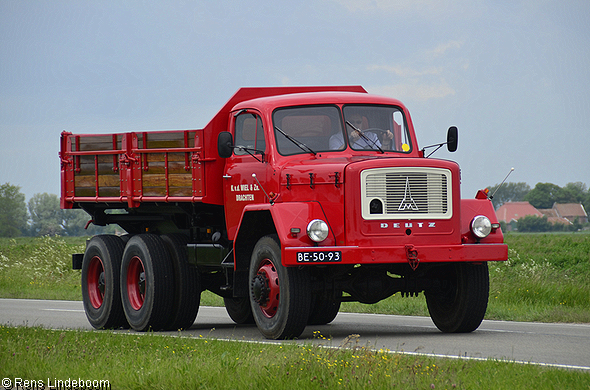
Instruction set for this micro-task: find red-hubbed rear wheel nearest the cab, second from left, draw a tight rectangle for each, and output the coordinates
[121,234,174,332]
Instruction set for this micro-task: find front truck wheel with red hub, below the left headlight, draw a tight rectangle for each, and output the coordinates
[249,235,311,340]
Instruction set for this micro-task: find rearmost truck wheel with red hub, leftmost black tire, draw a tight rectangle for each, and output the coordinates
[81,235,129,329]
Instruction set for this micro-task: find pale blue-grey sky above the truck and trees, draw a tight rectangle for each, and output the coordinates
[0,0,590,200]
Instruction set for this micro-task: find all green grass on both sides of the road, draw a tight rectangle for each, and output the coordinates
[0,234,590,389]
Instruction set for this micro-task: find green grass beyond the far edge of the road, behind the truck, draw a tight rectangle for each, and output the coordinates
[0,233,590,323]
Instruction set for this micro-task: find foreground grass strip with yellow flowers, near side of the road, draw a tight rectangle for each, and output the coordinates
[0,326,590,390]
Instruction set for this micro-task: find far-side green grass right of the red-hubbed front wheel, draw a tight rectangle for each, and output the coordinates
[341,233,590,323]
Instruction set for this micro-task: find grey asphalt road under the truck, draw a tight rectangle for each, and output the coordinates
[0,299,590,371]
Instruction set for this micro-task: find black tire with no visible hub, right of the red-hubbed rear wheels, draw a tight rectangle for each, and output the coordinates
[161,234,201,330]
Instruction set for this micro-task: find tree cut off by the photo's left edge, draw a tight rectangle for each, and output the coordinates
[0,183,27,237]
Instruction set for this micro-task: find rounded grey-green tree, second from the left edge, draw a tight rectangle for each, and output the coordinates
[29,192,63,236]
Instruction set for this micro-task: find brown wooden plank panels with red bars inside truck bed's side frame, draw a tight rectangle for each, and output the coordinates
[71,130,202,201]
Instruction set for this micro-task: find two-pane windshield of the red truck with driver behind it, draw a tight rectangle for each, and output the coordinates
[273,105,411,155]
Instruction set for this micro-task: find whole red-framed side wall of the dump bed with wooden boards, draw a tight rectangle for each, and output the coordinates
[60,130,217,208]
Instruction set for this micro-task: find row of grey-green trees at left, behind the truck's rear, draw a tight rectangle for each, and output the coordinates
[0,183,115,237]
